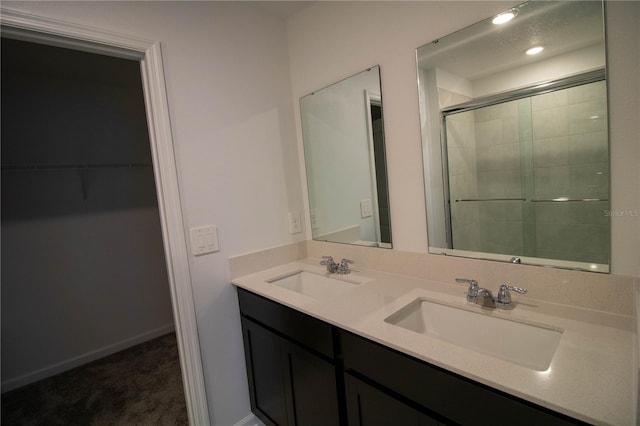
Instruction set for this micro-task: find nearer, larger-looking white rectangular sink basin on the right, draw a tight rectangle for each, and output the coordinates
[385,298,563,371]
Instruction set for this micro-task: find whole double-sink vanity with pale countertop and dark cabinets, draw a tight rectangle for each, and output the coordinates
[233,259,635,425]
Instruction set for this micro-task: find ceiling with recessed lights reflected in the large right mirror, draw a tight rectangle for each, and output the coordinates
[418,1,604,81]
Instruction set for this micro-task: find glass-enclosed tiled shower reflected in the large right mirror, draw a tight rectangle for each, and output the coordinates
[443,72,609,264]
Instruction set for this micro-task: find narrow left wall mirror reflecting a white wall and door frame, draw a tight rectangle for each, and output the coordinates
[300,66,391,248]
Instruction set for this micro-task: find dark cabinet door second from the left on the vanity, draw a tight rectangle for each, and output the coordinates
[282,339,340,426]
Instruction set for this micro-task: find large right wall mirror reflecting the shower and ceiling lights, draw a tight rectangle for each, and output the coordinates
[417,1,610,272]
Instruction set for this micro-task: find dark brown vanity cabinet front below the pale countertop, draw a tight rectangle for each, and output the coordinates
[238,288,584,426]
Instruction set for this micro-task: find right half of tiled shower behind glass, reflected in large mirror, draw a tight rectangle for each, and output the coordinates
[531,81,610,263]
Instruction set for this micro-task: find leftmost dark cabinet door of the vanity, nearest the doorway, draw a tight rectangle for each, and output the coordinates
[242,318,289,426]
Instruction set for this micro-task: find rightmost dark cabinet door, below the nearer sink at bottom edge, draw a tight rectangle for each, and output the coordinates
[345,374,438,426]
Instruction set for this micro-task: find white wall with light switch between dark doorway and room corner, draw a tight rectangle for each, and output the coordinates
[3,2,304,425]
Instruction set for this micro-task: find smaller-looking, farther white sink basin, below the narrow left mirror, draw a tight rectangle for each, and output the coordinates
[267,271,360,300]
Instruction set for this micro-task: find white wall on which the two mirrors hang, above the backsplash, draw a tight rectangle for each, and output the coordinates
[287,1,640,275]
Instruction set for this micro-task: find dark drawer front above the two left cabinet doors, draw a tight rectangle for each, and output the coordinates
[238,288,334,359]
